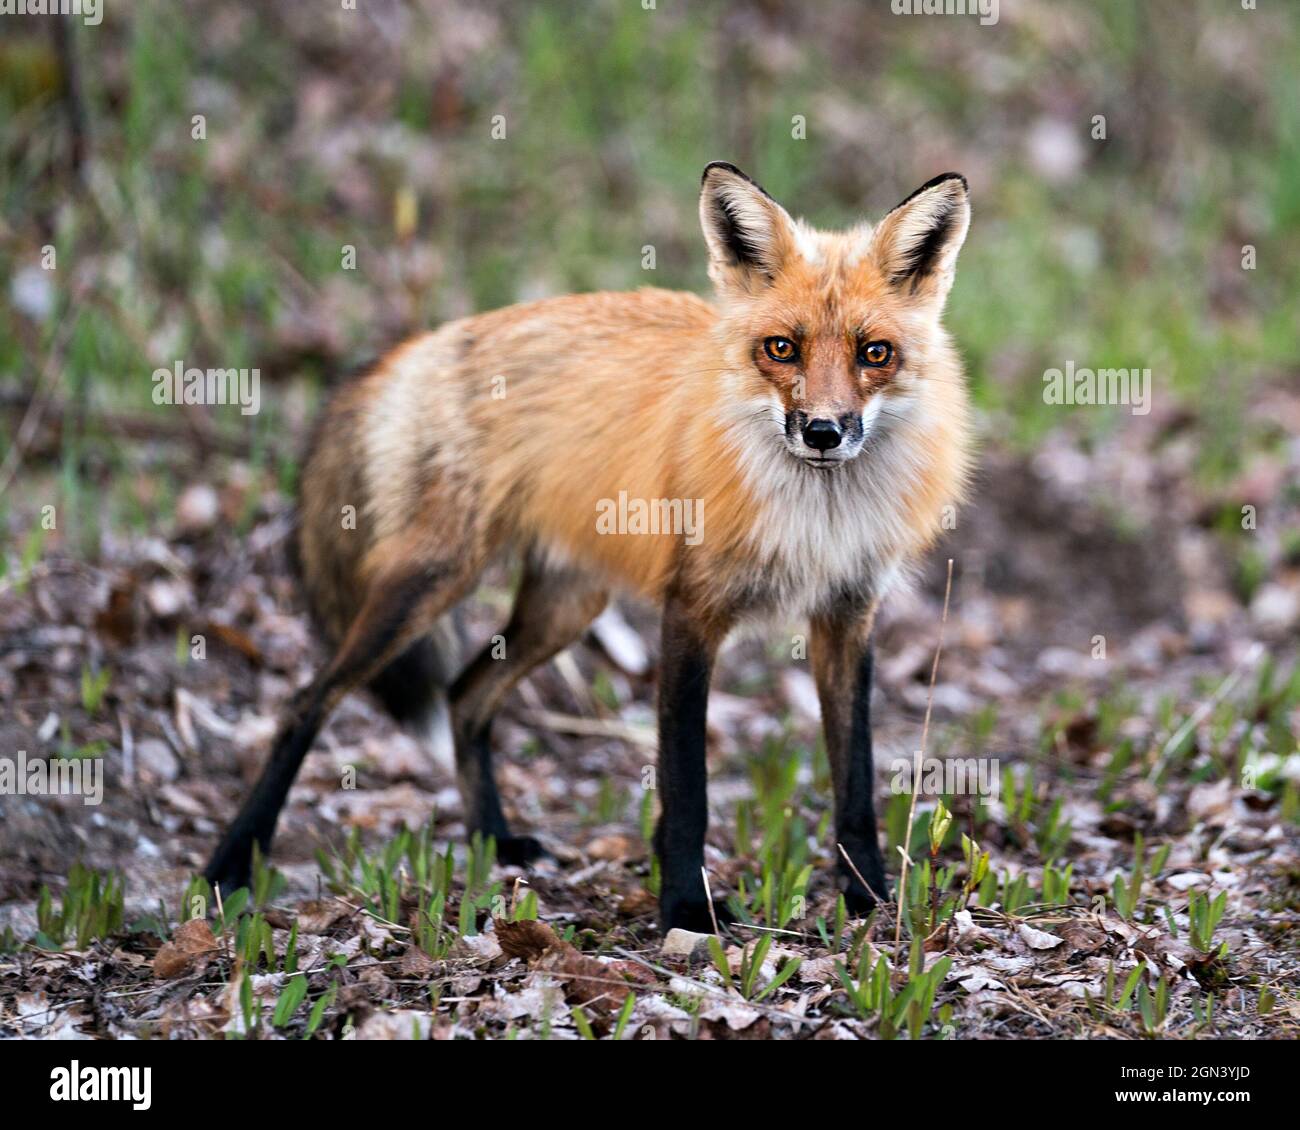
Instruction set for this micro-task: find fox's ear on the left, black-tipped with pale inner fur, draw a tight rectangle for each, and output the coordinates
[699,161,794,291]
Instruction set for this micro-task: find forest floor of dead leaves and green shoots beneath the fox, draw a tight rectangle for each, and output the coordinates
[0,382,1300,1039]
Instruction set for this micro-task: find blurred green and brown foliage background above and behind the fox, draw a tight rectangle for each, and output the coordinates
[0,0,1300,554]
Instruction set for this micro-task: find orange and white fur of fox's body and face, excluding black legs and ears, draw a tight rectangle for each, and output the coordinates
[302,170,969,636]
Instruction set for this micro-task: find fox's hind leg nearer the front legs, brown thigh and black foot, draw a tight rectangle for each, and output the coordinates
[451,555,608,863]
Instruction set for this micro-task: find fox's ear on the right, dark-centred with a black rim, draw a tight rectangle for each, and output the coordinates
[871,173,971,304]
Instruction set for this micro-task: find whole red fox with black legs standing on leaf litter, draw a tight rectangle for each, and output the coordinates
[205,161,970,930]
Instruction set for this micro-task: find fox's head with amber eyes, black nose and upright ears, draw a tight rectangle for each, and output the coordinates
[699,161,970,471]
